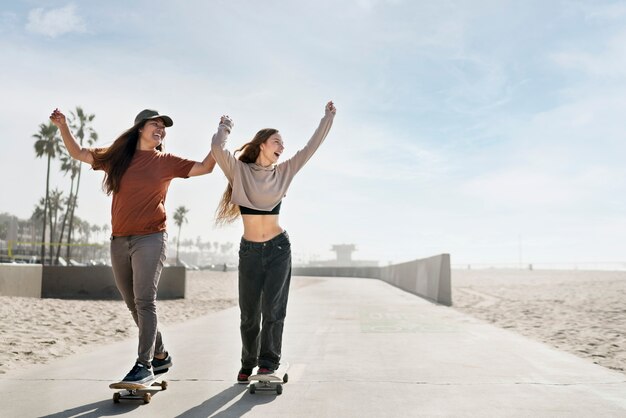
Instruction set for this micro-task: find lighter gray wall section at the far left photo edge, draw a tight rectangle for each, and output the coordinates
[0,264,41,298]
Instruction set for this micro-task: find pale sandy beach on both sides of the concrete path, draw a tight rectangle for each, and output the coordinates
[0,270,626,373]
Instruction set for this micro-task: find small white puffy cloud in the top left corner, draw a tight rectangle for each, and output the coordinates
[26,4,87,38]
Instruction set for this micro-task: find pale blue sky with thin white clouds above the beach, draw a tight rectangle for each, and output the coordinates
[0,0,626,265]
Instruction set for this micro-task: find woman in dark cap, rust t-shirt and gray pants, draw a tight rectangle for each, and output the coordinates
[50,109,215,386]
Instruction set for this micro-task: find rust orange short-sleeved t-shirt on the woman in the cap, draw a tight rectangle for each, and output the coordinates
[94,150,195,237]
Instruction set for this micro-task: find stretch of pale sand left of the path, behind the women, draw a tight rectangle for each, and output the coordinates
[0,271,237,373]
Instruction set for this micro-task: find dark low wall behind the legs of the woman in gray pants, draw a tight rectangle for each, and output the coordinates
[41,266,186,300]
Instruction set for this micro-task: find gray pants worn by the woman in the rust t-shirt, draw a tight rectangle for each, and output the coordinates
[111,231,167,366]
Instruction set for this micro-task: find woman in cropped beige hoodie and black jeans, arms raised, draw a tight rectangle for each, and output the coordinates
[211,101,336,383]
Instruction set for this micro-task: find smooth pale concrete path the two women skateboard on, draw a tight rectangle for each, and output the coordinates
[0,278,626,418]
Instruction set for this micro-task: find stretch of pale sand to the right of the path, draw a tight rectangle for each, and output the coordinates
[452,270,626,374]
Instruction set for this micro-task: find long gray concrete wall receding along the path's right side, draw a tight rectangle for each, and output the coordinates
[292,254,452,306]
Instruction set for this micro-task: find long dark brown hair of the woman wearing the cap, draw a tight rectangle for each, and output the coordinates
[92,120,163,195]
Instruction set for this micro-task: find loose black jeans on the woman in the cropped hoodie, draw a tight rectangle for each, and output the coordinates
[239,232,291,369]
